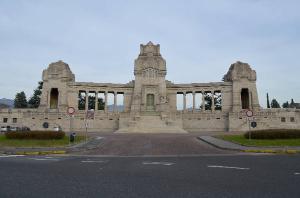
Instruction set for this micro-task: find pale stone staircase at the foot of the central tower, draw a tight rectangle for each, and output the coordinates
[116,112,187,133]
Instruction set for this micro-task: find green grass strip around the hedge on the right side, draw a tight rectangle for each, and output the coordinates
[217,135,300,146]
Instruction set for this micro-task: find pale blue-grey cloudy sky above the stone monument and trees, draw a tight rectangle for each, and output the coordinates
[0,0,300,106]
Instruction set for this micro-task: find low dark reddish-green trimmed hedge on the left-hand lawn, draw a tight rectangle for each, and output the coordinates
[5,131,65,140]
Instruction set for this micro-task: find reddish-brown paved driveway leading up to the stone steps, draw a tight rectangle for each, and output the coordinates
[76,133,233,156]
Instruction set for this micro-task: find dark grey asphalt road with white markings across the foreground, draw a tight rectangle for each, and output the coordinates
[0,154,300,198]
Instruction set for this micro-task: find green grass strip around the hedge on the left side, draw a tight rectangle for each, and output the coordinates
[0,135,85,147]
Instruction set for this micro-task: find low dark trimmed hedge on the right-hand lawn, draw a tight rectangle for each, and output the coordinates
[244,129,300,139]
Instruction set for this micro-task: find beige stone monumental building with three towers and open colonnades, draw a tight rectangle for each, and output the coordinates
[0,42,300,133]
